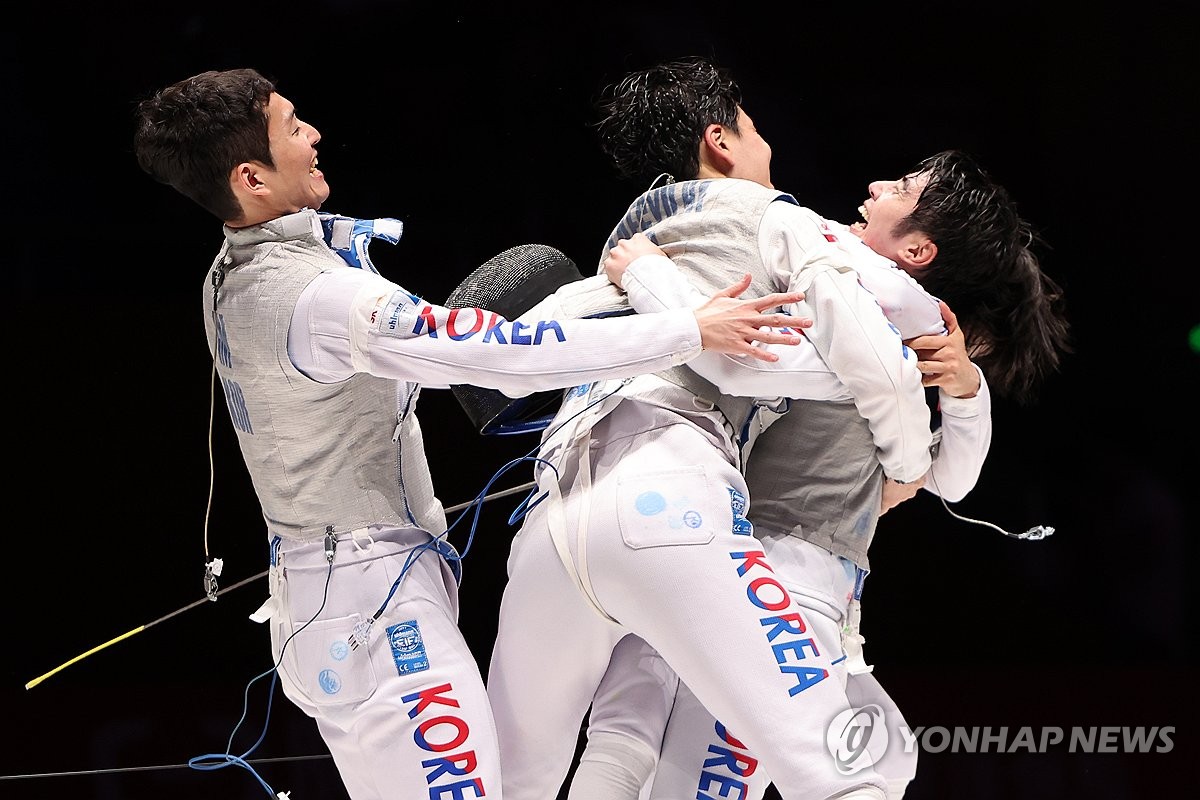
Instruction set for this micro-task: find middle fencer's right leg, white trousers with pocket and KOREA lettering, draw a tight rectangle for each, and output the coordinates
[576,413,884,800]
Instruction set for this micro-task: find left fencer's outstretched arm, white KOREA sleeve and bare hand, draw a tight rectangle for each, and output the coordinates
[289,270,786,396]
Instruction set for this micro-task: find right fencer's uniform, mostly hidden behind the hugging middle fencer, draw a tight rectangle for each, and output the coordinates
[572,214,991,800]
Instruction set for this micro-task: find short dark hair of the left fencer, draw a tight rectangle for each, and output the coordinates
[133,70,275,221]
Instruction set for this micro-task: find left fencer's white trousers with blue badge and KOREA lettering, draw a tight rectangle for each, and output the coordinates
[267,529,500,796]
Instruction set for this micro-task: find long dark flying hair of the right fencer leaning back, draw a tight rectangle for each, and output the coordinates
[894,150,1072,403]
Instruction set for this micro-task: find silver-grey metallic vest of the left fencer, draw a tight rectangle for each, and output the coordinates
[204,211,446,541]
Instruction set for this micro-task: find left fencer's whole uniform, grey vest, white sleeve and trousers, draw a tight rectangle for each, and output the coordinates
[204,210,729,800]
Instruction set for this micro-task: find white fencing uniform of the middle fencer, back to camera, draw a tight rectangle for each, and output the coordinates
[488,179,930,800]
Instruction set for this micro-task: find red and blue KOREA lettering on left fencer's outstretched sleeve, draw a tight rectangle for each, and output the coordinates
[371,291,566,345]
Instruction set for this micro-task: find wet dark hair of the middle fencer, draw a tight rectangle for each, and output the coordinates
[596,58,742,181]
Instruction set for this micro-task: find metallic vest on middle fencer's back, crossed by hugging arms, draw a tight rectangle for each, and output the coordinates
[600,178,799,460]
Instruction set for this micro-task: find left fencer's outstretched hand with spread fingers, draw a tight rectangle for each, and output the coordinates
[695,272,812,361]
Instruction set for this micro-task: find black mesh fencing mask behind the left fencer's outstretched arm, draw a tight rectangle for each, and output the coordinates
[444,245,634,435]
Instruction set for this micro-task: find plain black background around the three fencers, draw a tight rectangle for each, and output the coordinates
[0,0,1200,800]
